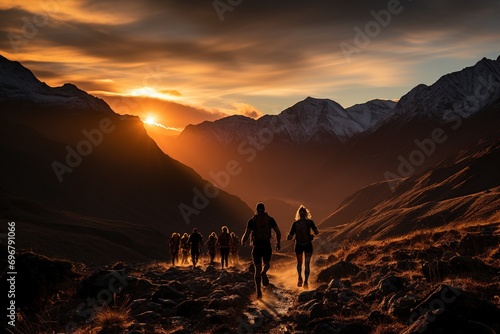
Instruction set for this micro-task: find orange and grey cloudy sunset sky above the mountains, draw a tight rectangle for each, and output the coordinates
[0,0,500,129]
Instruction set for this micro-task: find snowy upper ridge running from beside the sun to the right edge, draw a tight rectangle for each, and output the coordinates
[180,57,500,146]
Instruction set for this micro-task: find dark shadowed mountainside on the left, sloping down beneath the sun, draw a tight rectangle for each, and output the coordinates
[0,57,253,263]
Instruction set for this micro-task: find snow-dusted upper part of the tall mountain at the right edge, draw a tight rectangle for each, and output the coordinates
[390,56,500,123]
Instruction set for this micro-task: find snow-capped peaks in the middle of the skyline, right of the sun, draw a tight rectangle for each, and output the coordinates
[180,97,396,146]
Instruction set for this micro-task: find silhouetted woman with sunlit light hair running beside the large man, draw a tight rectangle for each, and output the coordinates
[287,205,319,288]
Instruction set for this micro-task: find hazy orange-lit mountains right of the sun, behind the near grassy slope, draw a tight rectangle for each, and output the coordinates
[163,58,500,224]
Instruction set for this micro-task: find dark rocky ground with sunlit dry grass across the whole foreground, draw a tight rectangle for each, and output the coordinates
[2,223,500,334]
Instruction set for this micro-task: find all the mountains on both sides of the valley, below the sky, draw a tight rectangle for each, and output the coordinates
[0,56,500,263]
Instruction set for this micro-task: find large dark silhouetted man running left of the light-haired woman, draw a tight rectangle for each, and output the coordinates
[241,203,281,299]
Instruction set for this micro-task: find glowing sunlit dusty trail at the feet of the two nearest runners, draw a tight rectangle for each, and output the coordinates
[238,260,315,334]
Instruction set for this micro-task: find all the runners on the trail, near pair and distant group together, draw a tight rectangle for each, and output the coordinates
[169,203,319,299]
